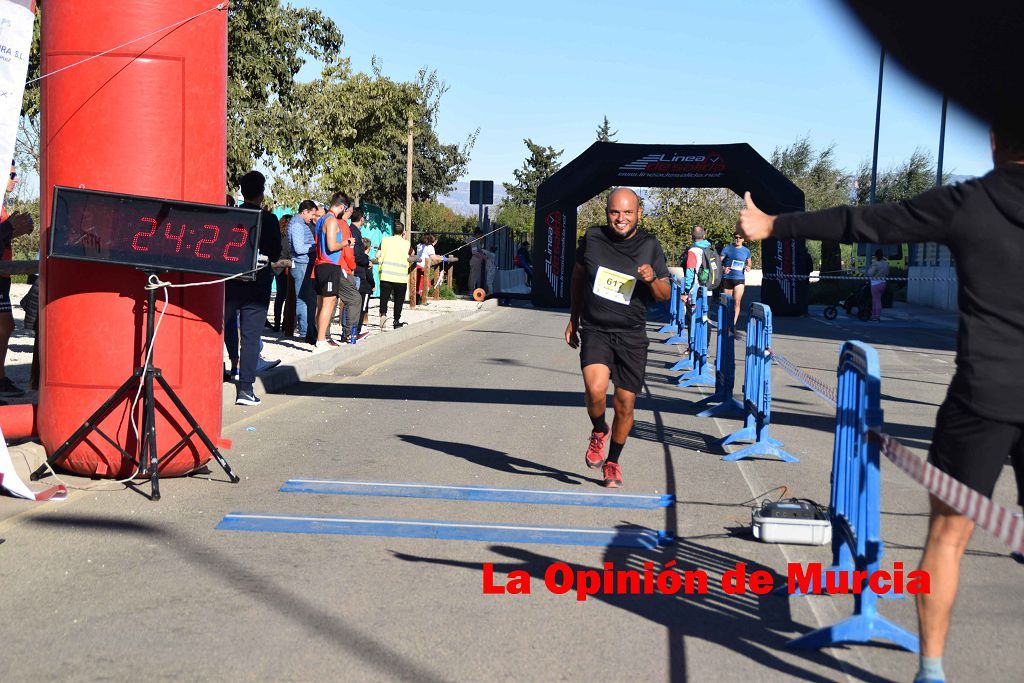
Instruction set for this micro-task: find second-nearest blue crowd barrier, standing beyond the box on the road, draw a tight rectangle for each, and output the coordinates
[722,303,800,463]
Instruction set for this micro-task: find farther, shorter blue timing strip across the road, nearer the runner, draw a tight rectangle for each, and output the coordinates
[281,479,676,510]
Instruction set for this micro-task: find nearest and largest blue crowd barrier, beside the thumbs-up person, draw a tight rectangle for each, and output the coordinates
[787,341,918,652]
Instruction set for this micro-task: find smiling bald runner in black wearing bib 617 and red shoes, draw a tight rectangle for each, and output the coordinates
[565,187,671,488]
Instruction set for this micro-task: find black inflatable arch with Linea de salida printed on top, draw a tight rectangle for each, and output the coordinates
[532,142,809,315]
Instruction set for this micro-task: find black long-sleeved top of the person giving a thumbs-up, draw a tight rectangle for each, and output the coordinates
[774,165,1024,424]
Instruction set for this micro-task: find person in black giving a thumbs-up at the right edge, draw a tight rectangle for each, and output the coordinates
[738,125,1024,681]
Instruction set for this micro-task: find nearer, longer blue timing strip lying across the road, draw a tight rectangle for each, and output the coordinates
[217,512,674,549]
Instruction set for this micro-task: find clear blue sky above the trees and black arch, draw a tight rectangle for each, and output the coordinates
[309,0,991,187]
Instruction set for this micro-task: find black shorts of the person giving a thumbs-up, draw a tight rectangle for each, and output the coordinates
[928,396,1024,505]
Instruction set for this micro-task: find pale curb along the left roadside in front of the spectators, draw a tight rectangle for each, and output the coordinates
[223,299,498,407]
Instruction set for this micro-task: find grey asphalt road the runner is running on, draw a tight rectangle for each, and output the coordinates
[0,308,1024,681]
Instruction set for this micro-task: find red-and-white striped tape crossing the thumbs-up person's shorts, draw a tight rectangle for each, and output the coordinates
[867,429,1024,553]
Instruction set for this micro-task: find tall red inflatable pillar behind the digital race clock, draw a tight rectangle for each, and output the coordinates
[37,0,227,477]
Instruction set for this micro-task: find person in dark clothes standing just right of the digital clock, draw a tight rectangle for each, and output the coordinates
[224,171,281,405]
